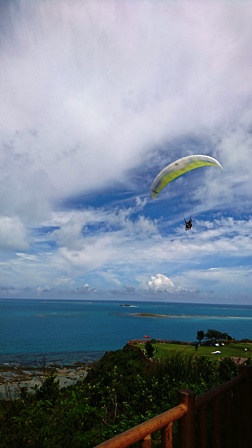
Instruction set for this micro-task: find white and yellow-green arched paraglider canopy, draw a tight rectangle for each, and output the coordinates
[151,155,223,199]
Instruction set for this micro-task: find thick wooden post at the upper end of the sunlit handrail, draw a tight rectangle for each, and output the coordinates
[179,389,195,448]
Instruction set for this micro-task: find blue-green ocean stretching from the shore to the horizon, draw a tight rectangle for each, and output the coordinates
[0,299,252,366]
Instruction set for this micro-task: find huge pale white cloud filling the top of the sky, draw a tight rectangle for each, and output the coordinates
[0,0,252,219]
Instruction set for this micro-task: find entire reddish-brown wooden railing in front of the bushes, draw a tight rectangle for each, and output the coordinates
[96,366,252,448]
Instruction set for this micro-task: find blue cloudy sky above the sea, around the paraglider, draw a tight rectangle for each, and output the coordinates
[0,0,252,305]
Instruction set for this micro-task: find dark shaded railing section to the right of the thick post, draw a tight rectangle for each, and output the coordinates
[194,366,252,448]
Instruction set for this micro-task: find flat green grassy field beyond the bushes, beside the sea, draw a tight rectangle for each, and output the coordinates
[137,342,252,358]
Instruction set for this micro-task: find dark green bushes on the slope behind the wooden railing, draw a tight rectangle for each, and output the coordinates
[0,343,250,448]
